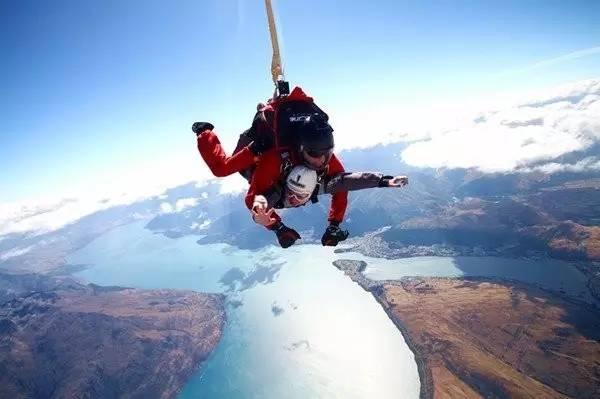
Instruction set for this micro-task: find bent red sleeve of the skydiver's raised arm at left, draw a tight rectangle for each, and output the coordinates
[198,131,255,177]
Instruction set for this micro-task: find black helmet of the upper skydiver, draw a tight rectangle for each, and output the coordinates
[290,113,334,157]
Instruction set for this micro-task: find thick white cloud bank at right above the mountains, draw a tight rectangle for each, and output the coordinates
[402,80,600,172]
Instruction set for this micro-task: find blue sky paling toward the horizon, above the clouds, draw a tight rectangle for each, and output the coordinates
[0,0,600,202]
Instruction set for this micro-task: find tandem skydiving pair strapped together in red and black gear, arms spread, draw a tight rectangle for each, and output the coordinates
[192,87,408,248]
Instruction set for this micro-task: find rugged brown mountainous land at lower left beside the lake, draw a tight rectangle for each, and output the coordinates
[0,274,228,396]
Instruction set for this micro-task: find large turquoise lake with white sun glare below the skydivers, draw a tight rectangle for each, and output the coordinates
[68,223,420,399]
